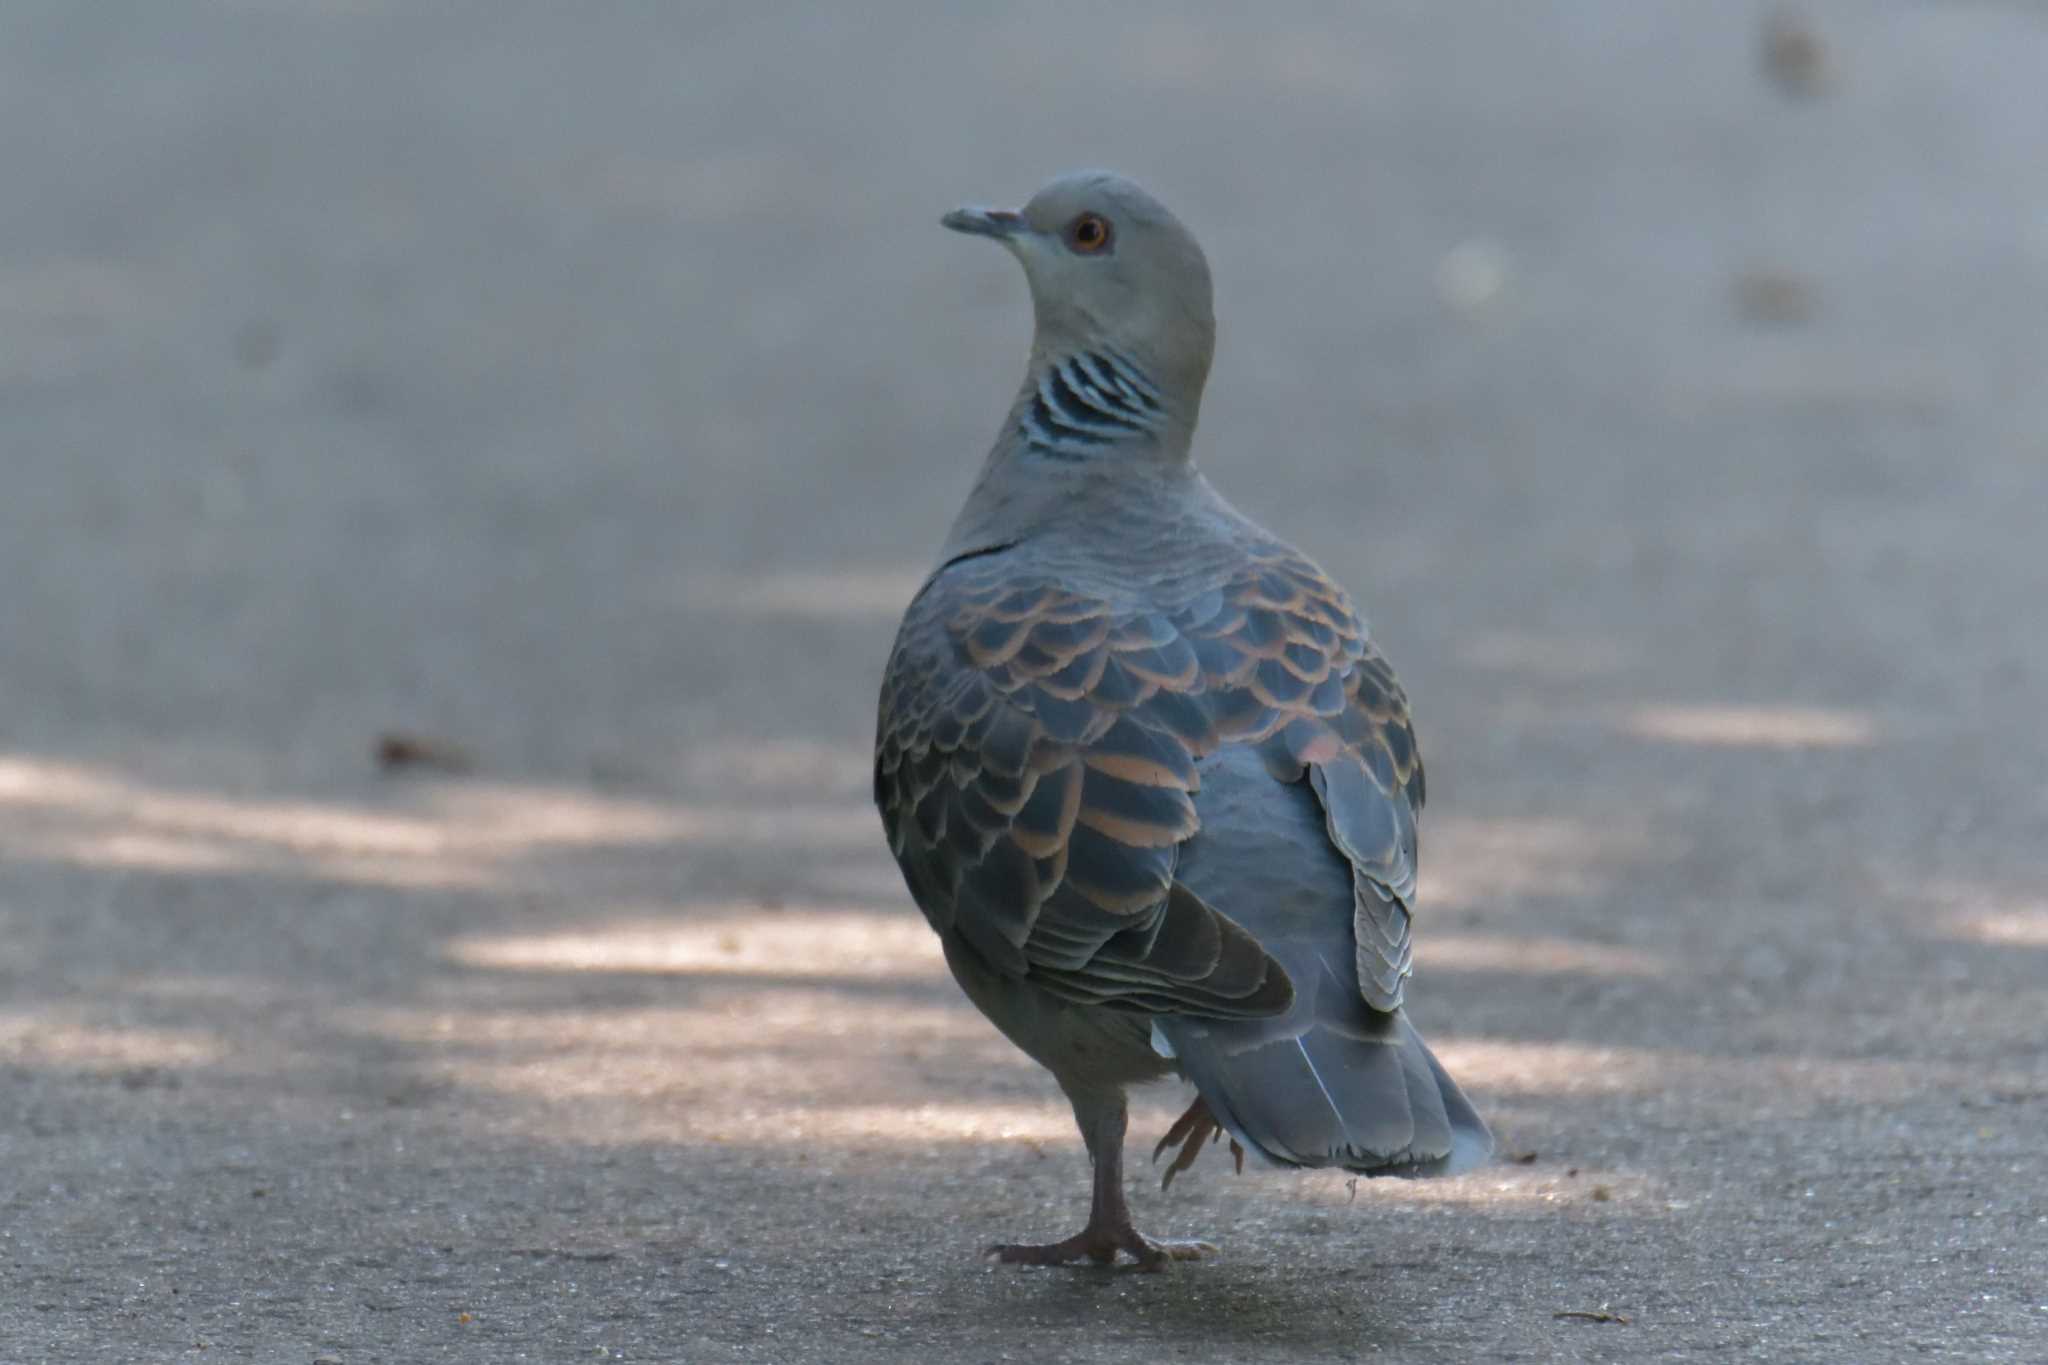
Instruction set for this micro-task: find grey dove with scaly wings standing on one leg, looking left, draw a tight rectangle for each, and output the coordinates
[874,172,1493,1269]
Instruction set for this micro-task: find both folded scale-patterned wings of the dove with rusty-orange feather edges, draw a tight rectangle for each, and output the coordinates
[874,546,1421,1017]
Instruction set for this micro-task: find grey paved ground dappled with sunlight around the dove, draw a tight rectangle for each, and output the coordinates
[0,0,2048,1365]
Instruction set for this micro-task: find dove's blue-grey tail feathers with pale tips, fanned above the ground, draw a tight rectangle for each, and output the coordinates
[1155,1003,1493,1177]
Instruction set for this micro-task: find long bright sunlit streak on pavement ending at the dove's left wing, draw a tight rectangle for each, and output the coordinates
[449,907,942,978]
